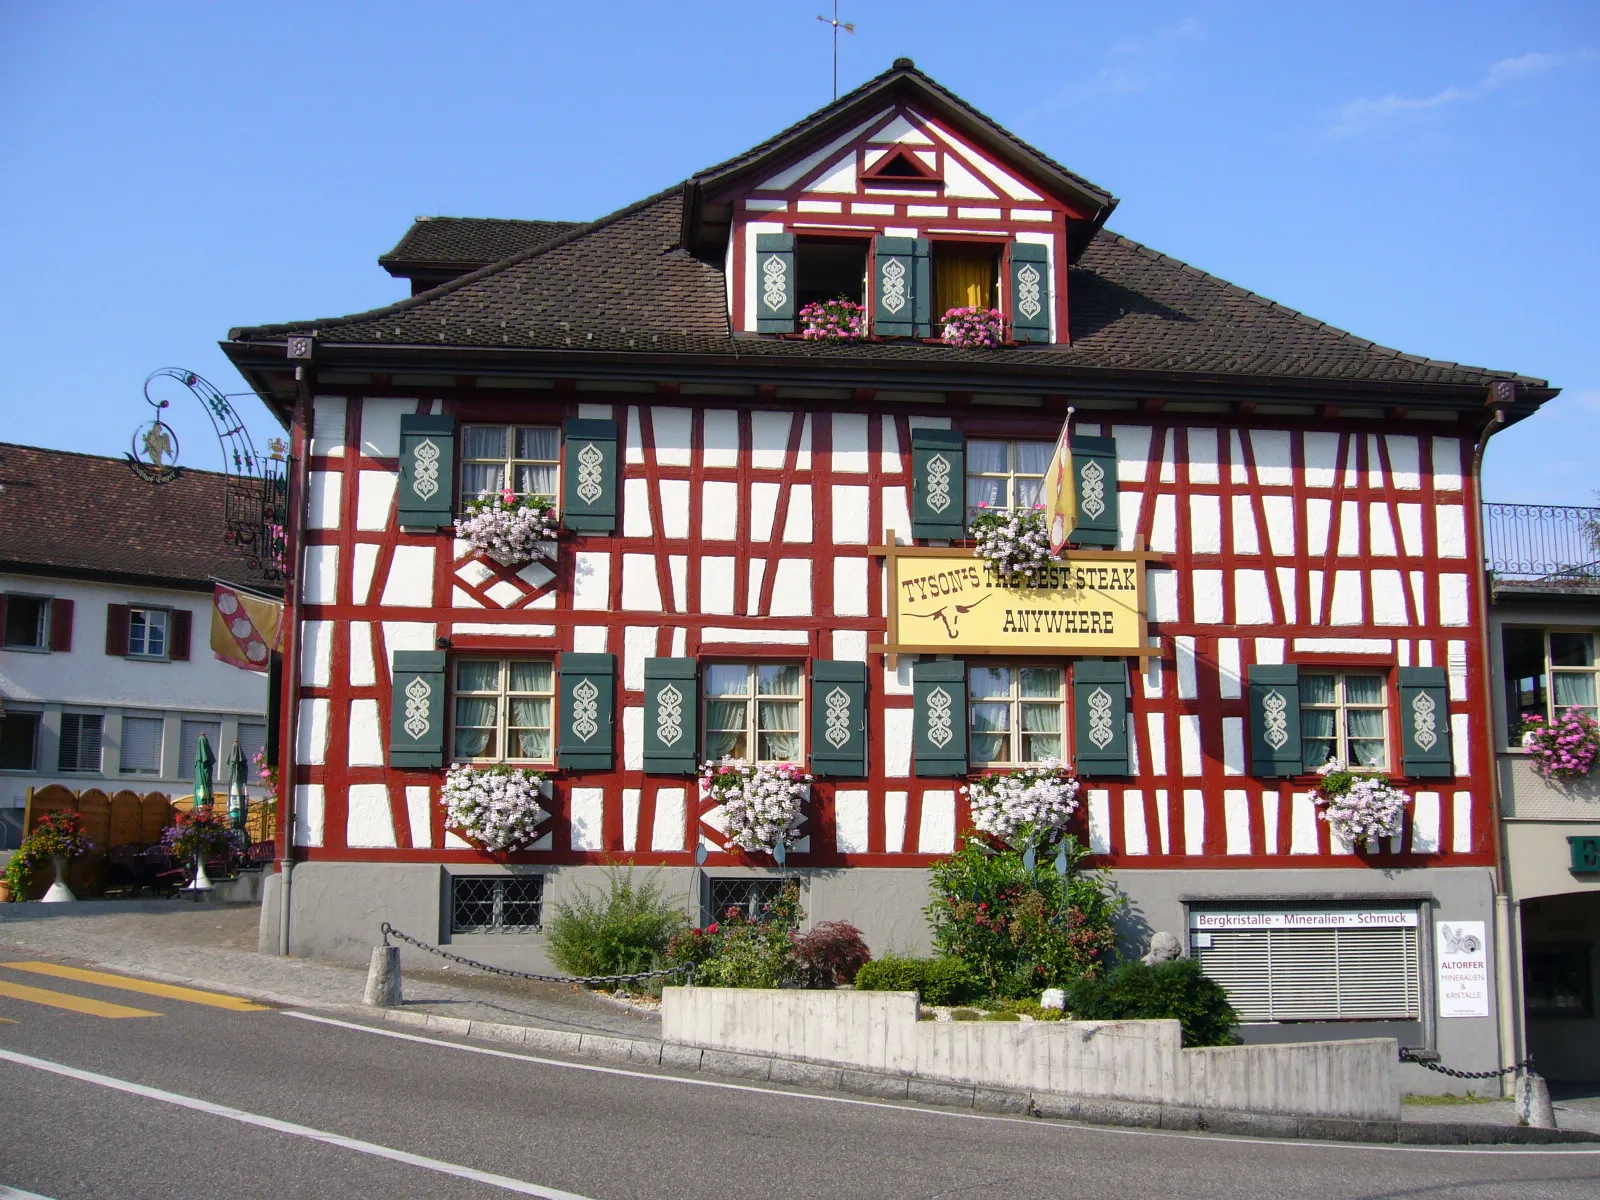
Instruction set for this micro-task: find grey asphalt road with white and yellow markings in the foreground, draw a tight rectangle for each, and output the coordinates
[0,954,1600,1200]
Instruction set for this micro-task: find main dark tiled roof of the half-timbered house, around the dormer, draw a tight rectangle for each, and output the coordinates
[230,187,1544,387]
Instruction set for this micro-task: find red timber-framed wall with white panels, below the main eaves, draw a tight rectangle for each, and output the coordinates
[293,387,1493,869]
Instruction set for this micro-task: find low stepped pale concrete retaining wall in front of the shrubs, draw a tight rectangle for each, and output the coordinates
[661,987,1400,1120]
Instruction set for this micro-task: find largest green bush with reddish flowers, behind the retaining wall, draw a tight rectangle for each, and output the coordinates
[925,835,1122,998]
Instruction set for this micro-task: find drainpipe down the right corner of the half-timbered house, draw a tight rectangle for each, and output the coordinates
[1472,396,1522,1096]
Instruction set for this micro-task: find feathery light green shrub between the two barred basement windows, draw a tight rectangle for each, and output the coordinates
[549,867,688,976]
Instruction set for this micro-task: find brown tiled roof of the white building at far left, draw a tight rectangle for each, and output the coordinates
[0,442,259,586]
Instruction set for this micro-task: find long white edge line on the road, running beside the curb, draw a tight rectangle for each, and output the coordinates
[288,1011,1600,1157]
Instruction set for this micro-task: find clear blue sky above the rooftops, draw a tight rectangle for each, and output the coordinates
[0,0,1600,504]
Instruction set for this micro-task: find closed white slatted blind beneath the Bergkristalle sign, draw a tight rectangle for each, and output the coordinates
[1194,926,1422,1021]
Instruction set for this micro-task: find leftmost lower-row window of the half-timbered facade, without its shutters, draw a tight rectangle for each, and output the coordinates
[454,659,555,763]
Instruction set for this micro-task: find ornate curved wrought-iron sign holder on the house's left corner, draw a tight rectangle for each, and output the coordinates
[126,366,290,582]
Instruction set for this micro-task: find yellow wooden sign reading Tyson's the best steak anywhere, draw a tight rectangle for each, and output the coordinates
[872,546,1162,658]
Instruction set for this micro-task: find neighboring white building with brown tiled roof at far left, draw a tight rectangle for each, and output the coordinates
[0,443,267,846]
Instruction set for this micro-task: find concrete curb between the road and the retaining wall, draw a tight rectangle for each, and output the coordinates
[382,1008,1600,1146]
